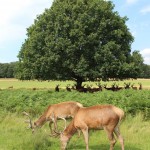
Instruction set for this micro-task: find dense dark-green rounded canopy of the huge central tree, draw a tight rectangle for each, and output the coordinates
[17,0,143,86]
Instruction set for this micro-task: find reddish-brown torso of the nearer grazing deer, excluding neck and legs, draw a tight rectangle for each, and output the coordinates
[74,105,124,129]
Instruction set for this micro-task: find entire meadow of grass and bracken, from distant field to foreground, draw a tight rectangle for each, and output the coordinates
[0,79,150,150]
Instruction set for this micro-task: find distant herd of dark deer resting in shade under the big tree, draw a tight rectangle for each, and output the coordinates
[55,82,142,93]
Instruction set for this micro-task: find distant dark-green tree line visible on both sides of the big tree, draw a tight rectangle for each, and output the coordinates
[0,62,150,78]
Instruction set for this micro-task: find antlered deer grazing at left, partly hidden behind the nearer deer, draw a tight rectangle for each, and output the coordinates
[23,101,83,134]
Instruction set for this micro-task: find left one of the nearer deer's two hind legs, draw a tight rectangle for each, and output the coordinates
[104,127,116,150]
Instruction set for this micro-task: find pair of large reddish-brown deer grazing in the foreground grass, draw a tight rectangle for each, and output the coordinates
[23,101,124,150]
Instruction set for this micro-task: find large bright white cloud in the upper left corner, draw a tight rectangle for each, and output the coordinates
[0,0,53,44]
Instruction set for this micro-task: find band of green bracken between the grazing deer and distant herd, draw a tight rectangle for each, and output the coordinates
[0,89,150,119]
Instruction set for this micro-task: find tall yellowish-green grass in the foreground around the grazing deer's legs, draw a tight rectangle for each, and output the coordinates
[0,113,150,150]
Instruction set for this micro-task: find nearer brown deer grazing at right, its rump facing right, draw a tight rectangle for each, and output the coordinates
[57,105,124,150]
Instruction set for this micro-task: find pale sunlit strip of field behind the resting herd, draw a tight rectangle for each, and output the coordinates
[0,79,150,89]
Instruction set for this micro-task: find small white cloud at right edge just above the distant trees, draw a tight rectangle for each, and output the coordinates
[140,48,150,65]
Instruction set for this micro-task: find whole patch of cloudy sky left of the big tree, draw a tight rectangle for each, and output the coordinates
[0,0,53,63]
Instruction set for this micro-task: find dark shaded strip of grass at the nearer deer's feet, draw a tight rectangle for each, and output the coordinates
[67,144,142,150]
